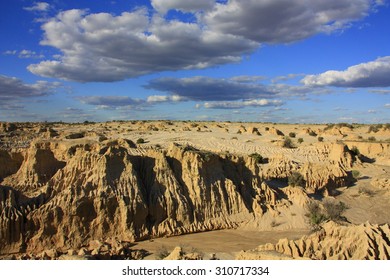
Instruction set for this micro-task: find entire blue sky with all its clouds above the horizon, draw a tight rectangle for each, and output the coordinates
[0,0,390,123]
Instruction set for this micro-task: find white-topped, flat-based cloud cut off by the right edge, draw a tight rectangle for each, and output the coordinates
[302,56,390,87]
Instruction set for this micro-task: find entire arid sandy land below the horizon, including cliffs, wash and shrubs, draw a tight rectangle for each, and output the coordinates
[0,121,390,259]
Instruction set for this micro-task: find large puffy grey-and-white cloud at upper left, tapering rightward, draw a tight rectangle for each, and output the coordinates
[28,9,258,82]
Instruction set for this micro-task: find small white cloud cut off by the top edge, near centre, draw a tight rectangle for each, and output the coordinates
[151,0,215,14]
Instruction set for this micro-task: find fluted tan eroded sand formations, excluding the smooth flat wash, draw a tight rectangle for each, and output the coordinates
[0,122,390,259]
